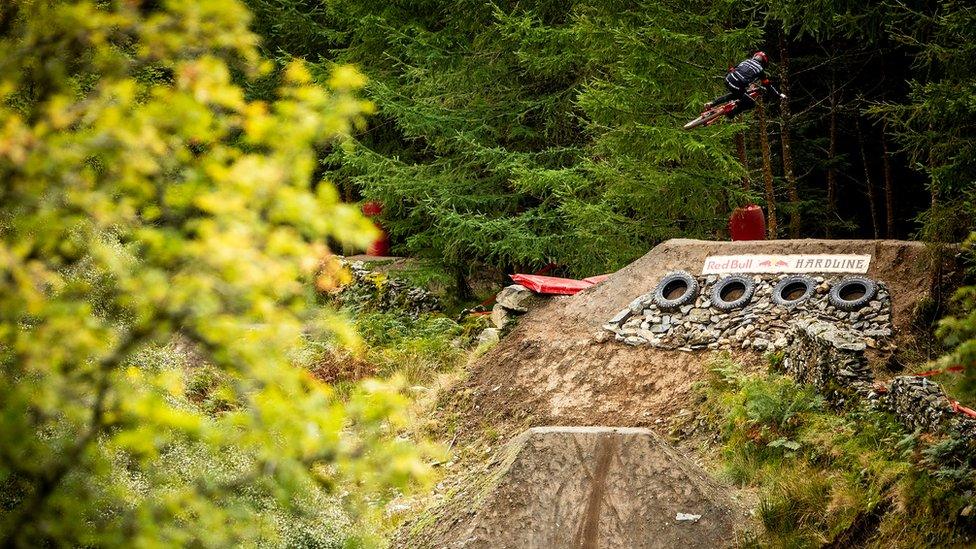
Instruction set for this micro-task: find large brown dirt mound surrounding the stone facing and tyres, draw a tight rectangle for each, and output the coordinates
[462,240,933,428]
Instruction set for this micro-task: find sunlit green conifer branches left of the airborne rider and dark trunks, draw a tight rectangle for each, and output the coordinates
[250,0,755,275]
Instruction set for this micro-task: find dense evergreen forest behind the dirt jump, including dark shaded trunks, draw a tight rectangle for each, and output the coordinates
[247,0,976,255]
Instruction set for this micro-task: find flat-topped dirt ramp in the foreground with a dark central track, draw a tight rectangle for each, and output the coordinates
[424,427,735,549]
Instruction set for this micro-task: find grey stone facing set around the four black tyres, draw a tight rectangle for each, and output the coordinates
[599,275,893,351]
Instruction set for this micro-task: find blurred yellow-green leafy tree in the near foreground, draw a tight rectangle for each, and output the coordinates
[0,0,426,546]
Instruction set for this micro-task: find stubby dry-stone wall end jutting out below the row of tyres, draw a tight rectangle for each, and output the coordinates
[783,320,874,404]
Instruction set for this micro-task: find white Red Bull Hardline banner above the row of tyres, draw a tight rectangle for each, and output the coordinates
[702,254,871,275]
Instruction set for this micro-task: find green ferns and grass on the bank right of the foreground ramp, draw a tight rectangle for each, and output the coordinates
[705,360,976,547]
